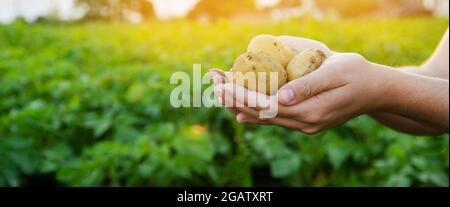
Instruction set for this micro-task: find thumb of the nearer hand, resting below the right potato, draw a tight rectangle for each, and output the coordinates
[278,68,334,106]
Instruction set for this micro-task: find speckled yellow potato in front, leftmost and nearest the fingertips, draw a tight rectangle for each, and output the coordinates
[232,52,287,95]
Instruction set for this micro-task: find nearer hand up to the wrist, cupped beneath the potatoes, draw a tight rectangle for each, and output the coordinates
[229,51,384,134]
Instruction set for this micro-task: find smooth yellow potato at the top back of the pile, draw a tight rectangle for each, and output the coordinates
[247,35,297,68]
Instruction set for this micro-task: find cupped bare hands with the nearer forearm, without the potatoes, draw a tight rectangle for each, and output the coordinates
[209,37,448,134]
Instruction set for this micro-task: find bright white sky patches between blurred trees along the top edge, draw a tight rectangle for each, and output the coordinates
[0,0,278,23]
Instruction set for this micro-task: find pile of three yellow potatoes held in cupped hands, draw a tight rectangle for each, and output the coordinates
[231,35,327,95]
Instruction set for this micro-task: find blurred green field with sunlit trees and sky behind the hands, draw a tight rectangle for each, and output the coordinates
[0,0,449,186]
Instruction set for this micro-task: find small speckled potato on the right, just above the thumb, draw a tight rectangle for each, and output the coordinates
[286,49,327,81]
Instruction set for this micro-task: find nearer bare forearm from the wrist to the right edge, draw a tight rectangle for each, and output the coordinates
[376,65,449,132]
